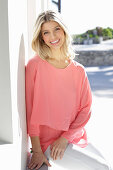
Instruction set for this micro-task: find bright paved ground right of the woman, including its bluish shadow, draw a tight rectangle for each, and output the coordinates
[86,66,113,167]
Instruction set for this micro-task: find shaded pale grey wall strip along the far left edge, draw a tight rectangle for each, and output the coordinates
[0,0,13,144]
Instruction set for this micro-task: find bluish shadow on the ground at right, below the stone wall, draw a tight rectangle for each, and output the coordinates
[87,66,113,98]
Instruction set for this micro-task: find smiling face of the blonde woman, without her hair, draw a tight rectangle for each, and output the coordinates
[41,21,65,50]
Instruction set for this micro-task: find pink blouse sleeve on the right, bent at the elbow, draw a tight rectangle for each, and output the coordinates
[61,67,92,142]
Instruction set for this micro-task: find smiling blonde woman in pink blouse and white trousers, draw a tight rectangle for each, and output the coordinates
[26,10,109,170]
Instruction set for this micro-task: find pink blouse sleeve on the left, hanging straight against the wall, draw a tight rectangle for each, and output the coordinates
[25,60,39,136]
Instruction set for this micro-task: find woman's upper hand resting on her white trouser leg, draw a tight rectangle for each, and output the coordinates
[50,137,68,160]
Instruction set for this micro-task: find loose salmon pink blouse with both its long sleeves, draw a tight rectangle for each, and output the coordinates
[25,55,92,147]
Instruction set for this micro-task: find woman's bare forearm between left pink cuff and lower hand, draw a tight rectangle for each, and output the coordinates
[30,136,42,152]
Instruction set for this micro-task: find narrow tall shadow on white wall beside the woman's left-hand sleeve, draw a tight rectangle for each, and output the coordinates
[17,34,27,170]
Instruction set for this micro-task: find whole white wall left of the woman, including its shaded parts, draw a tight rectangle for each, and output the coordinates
[0,0,28,170]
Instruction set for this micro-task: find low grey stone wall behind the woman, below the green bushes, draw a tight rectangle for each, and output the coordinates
[75,50,113,66]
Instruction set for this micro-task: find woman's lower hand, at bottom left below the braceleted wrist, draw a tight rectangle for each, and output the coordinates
[28,151,51,169]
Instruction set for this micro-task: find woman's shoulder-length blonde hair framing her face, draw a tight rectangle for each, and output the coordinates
[32,10,75,59]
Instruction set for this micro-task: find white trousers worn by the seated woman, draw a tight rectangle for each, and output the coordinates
[27,144,112,170]
